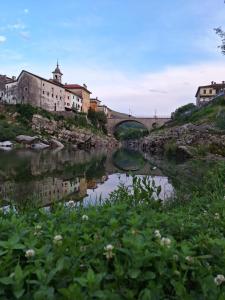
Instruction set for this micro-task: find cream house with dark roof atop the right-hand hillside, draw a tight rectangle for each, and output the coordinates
[195,81,225,106]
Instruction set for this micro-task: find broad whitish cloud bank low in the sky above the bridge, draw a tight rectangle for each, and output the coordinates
[62,59,225,116]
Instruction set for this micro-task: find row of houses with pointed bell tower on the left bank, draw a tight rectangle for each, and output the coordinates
[0,62,110,116]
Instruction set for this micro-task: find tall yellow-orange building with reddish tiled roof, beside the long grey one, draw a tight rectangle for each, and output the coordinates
[64,84,91,113]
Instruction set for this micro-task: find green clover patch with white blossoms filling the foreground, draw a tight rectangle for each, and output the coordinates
[0,163,225,300]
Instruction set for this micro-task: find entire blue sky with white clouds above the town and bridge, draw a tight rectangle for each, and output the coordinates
[0,0,225,116]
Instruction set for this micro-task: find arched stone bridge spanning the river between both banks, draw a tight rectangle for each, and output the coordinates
[107,116,170,134]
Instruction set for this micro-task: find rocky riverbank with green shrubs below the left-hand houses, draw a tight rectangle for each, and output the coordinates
[0,105,119,149]
